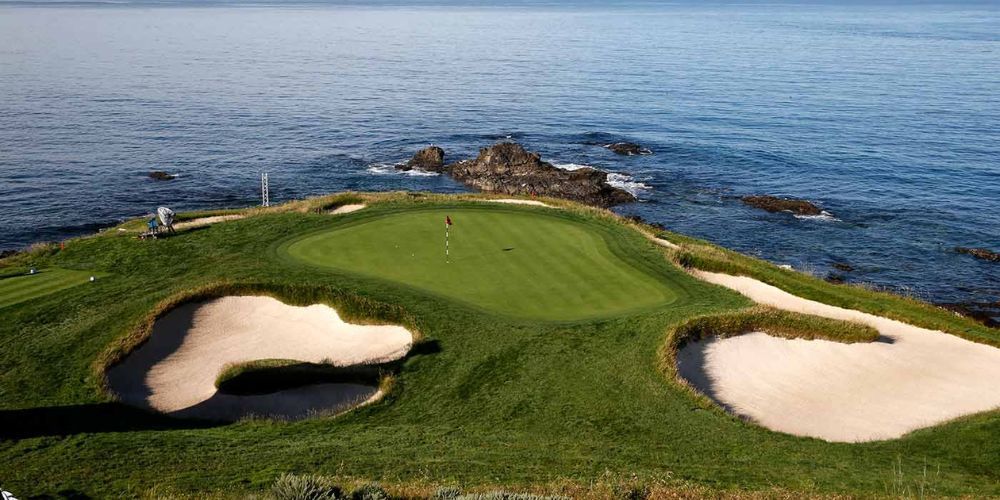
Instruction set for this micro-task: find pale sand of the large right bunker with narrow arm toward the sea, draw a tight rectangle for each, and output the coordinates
[677,271,1000,442]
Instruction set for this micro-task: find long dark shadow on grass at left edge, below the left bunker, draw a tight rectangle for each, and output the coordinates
[0,403,220,441]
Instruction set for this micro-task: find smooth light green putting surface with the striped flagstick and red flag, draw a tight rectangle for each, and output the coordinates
[282,208,676,320]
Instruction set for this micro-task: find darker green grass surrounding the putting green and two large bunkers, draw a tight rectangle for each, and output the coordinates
[0,192,1000,496]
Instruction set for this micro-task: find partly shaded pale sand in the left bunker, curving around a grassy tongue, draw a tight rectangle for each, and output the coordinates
[108,296,413,421]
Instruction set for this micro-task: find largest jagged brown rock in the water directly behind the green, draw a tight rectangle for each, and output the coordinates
[445,142,635,207]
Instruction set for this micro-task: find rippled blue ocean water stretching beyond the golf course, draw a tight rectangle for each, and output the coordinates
[0,2,1000,310]
